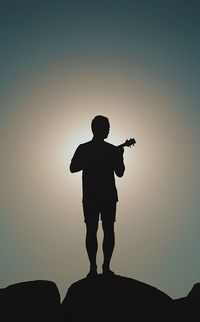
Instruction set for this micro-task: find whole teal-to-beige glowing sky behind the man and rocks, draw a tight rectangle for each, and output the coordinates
[0,0,200,298]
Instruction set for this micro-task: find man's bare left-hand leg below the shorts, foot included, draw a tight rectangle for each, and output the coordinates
[85,221,98,276]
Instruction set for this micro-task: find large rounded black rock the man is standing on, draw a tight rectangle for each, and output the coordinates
[62,275,173,322]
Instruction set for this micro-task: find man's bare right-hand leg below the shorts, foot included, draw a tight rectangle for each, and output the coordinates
[102,221,115,274]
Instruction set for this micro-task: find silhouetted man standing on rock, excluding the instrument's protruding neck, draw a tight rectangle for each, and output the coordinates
[70,115,125,277]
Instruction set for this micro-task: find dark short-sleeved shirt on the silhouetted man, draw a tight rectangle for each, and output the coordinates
[72,140,123,203]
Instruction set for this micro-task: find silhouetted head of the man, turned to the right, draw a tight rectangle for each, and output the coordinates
[91,115,110,139]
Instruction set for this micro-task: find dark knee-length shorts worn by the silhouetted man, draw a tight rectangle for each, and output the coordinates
[83,201,116,223]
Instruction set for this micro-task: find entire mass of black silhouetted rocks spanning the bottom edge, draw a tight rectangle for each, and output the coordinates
[0,275,200,322]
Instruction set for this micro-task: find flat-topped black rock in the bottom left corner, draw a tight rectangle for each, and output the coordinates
[0,281,60,322]
